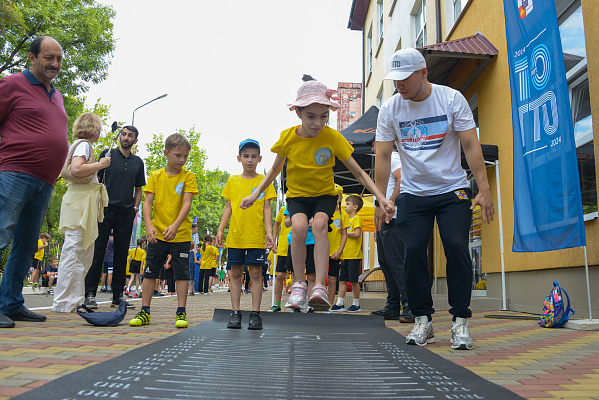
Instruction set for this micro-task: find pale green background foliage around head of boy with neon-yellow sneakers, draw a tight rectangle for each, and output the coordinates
[144,128,229,236]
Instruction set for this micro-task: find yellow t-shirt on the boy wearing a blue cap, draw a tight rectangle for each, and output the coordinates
[222,175,277,249]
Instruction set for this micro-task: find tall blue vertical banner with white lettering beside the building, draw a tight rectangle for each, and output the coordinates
[503,0,586,252]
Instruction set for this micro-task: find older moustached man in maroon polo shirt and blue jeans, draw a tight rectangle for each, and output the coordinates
[0,36,69,328]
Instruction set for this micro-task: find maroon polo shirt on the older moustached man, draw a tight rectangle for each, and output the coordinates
[0,71,69,186]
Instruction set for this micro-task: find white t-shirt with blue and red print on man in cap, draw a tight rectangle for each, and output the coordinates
[376,84,476,196]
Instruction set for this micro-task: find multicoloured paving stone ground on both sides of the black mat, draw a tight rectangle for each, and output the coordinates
[0,289,599,400]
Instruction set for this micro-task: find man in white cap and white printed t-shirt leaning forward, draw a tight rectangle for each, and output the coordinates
[375,49,495,350]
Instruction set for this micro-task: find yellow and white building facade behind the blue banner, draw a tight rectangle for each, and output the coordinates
[348,0,599,318]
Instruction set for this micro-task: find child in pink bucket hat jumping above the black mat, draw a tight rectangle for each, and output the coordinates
[241,81,395,311]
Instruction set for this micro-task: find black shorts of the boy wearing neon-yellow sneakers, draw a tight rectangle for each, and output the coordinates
[143,240,190,281]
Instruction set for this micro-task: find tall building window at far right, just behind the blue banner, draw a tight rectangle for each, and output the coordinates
[556,0,597,214]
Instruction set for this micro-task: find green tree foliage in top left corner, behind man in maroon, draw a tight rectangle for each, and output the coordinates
[0,0,115,132]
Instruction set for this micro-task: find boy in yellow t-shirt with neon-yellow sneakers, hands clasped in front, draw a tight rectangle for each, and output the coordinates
[129,133,198,328]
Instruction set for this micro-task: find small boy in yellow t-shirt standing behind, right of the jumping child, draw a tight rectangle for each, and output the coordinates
[331,195,364,312]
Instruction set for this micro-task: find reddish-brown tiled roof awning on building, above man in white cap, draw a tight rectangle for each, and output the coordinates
[418,32,499,93]
